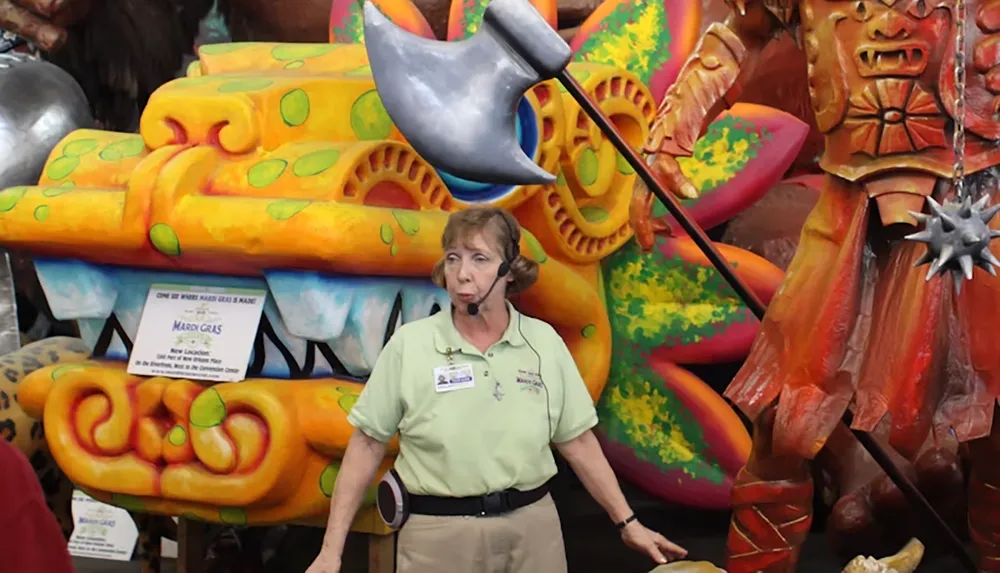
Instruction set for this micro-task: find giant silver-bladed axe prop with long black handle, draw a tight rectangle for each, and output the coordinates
[364,0,977,573]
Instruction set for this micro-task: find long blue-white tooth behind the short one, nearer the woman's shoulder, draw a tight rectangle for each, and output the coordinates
[329,279,400,376]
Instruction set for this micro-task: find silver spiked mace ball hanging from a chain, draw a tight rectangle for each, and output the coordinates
[906,195,1000,291]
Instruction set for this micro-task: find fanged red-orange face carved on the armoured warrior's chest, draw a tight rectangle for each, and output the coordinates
[836,0,954,78]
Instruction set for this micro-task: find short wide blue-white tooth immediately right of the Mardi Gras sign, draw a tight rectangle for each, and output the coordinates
[265,271,355,340]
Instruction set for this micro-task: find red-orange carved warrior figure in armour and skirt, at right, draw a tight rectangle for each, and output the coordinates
[632,0,1000,573]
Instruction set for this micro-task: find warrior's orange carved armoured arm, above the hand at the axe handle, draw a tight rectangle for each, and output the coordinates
[645,0,798,156]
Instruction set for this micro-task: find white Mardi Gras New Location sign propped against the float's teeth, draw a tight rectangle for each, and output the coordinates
[128,284,267,382]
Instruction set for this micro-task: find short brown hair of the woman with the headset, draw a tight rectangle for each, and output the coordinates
[431,207,538,294]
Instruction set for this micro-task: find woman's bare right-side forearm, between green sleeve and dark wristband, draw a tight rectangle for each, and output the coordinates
[555,430,632,523]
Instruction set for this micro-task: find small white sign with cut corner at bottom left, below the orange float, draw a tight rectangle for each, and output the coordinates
[69,490,139,561]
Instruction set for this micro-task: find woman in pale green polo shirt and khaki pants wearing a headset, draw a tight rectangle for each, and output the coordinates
[308,208,686,573]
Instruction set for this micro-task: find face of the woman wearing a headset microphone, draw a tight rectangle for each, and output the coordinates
[444,232,510,313]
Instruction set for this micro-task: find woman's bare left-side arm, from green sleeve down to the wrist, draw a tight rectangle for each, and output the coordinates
[322,429,386,560]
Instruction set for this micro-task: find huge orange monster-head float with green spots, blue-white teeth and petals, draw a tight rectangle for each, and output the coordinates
[0,0,807,544]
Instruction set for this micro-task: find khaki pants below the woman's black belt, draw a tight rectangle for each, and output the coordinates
[396,494,567,573]
